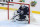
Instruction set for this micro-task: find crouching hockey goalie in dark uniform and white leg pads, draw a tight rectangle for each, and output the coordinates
[12,5,29,23]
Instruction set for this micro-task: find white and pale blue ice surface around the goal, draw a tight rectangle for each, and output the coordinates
[0,10,40,27]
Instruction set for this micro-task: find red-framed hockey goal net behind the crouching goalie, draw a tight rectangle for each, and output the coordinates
[8,2,30,23]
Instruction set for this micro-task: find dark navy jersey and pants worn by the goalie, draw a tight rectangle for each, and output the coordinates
[17,6,29,19]
